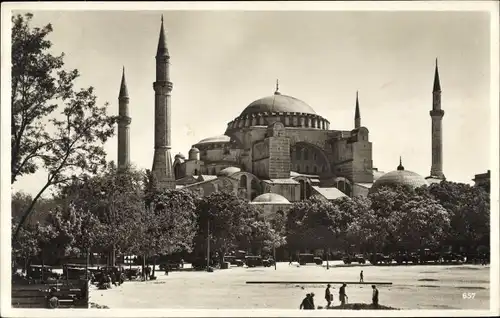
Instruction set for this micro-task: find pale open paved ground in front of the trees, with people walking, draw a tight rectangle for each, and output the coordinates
[91,262,490,309]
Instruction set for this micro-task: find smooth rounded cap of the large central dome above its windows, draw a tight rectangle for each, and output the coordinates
[240,93,316,116]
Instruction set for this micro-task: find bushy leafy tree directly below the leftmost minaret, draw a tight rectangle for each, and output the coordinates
[58,162,145,265]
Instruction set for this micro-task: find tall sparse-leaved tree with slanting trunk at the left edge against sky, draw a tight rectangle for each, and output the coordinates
[11,14,116,237]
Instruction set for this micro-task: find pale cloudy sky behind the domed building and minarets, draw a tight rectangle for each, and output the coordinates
[7,10,496,193]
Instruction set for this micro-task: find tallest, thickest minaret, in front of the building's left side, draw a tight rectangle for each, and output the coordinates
[152,15,175,189]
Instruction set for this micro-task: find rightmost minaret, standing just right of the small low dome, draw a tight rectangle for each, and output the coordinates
[429,59,445,180]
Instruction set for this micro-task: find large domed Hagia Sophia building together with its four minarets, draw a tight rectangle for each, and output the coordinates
[118,17,445,213]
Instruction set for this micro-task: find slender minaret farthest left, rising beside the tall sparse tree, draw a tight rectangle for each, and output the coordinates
[118,67,132,169]
